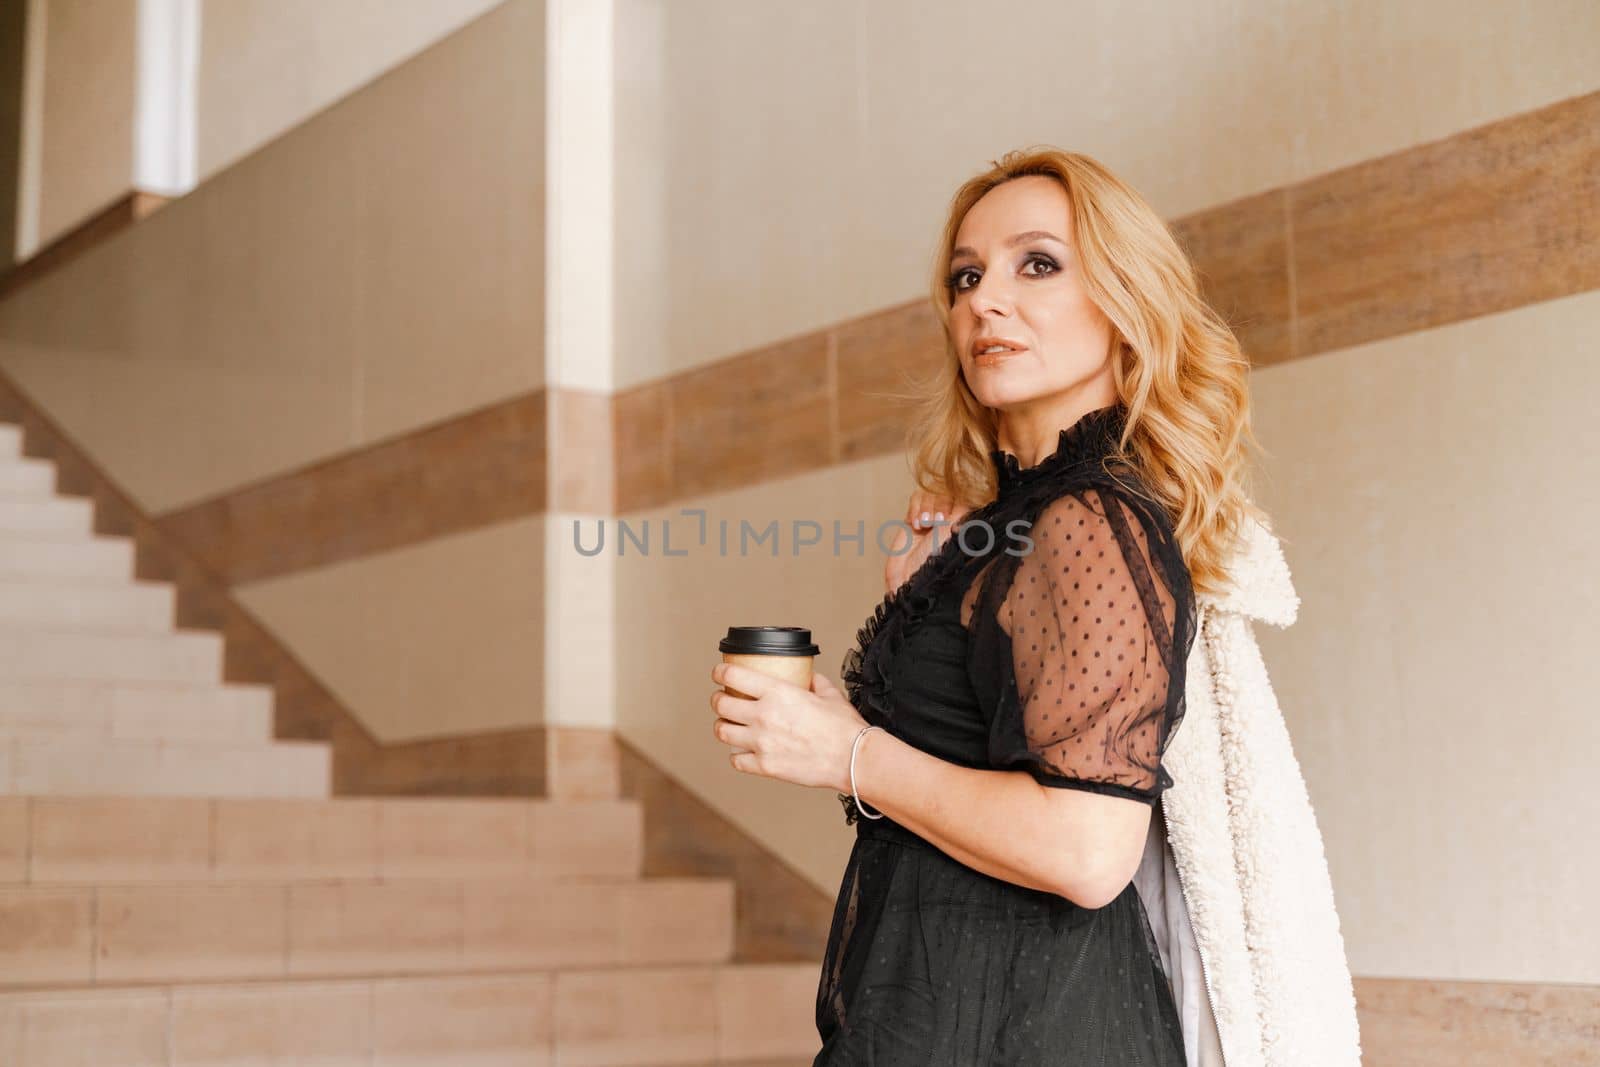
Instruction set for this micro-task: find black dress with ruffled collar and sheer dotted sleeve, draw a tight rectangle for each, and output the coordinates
[813,405,1195,1067]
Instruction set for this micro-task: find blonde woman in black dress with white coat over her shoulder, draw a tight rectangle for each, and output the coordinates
[712,149,1358,1067]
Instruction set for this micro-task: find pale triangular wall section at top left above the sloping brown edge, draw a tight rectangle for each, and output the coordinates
[195,0,501,181]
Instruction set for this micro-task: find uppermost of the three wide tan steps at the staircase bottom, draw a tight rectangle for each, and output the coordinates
[0,797,645,886]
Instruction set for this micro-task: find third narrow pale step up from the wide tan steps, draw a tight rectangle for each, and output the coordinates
[0,624,222,685]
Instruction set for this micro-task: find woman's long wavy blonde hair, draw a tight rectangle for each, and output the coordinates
[891,146,1270,593]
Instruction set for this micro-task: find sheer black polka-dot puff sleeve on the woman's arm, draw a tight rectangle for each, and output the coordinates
[970,488,1194,803]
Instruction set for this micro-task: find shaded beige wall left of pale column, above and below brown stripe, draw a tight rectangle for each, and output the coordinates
[0,0,544,741]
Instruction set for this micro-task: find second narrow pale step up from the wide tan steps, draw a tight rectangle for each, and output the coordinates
[0,678,274,745]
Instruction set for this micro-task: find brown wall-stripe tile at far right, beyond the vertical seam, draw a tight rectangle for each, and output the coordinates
[1288,93,1600,355]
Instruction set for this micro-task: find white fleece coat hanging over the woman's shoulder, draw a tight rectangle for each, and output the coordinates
[1134,511,1362,1067]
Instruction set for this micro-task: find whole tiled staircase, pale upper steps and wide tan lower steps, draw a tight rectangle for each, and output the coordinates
[0,424,818,1067]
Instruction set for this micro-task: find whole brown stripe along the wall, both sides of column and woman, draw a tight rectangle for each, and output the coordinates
[131,93,1600,566]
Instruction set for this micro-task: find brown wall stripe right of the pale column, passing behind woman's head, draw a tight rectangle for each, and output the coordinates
[613,93,1600,512]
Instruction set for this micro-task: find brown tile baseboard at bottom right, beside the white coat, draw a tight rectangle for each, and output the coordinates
[1355,977,1600,1067]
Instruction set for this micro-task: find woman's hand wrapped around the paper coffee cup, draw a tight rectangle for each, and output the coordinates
[710,662,867,792]
